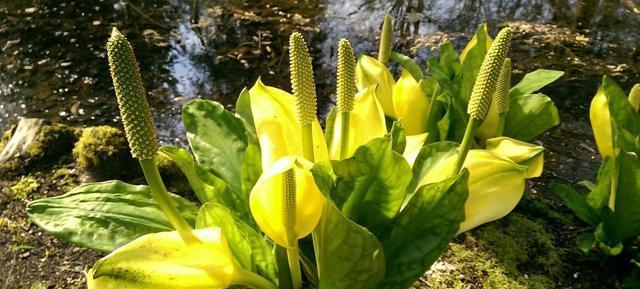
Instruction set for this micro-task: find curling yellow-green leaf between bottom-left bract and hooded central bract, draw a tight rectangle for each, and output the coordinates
[196,202,278,284]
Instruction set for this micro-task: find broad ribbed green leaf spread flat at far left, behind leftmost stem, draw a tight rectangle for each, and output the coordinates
[27,181,198,252]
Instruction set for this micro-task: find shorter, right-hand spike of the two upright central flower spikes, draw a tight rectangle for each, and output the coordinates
[337,39,356,112]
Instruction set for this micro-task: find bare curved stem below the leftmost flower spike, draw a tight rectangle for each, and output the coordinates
[140,159,191,231]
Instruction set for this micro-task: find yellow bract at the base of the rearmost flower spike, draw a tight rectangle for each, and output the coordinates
[356,55,397,118]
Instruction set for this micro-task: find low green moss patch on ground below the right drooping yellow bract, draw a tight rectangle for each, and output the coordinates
[419,213,565,289]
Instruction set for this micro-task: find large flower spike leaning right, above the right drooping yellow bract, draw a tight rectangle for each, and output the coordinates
[467,28,511,120]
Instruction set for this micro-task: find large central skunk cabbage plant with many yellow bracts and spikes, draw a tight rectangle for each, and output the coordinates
[27,18,542,289]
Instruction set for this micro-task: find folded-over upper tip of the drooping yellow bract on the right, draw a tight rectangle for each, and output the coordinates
[486,137,544,179]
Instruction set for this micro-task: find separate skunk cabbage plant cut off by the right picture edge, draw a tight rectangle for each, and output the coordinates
[554,76,640,255]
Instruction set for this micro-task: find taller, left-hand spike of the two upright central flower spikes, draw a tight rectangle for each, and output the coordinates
[289,32,316,126]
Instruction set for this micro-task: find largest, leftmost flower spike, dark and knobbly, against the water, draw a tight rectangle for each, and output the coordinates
[107,27,158,160]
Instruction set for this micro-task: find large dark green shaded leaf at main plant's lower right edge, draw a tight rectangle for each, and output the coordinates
[378,170,469,289]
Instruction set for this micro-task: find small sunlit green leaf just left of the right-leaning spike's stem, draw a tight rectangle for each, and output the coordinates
[405,141,458,195]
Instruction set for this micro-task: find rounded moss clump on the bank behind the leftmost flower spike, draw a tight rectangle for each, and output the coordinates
[73,126,140,180]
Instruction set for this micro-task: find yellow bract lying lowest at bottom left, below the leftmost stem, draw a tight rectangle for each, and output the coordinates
[87,228,235,289]
